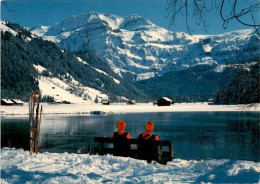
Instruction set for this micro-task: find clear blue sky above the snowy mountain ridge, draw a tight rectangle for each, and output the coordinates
[1,0,259,34]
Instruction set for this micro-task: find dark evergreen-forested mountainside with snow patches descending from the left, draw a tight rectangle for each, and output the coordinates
[0,22,145,102]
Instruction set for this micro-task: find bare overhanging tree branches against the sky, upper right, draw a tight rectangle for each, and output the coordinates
[167,0,260,34]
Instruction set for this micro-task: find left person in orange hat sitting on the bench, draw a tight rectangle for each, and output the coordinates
[112,120,131,156]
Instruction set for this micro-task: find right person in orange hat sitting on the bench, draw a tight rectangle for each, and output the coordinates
[137,121,159,163]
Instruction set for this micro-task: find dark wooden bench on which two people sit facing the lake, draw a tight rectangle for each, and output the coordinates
[94,137,173,165]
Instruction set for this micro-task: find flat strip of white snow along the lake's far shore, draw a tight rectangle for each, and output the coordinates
[0,103,260,115]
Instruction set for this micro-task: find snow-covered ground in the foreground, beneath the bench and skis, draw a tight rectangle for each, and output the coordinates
[0,148,260,184]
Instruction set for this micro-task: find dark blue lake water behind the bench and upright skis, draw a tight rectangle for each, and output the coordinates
[1,112,260,162]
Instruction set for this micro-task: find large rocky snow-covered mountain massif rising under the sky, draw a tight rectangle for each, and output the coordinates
[32,13,259,80]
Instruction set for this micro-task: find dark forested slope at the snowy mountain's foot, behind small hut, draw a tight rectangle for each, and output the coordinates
[136,64,243,100]
